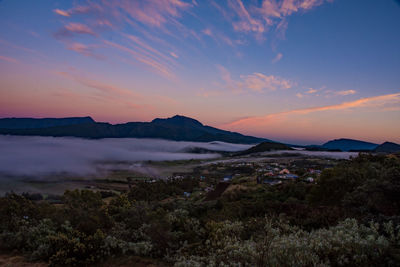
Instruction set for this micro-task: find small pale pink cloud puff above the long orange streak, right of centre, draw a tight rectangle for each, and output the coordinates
[217,66,294,93]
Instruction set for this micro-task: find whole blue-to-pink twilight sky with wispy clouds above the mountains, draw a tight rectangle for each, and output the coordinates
[0,0,400,147]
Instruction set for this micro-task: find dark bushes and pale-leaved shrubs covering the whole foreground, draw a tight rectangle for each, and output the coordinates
[0,154,400,266]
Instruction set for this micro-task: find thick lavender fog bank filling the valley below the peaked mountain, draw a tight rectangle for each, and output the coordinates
[0,135,251,177]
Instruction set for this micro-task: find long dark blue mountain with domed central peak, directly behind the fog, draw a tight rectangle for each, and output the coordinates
[0,115,270,144]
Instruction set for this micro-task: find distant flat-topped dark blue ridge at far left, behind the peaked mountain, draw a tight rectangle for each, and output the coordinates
[0,117,95,129]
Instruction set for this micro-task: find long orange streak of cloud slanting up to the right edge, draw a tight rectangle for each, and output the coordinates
[223,93,400,128]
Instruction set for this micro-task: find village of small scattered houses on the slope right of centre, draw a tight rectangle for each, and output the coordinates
[162,158,338,200]
